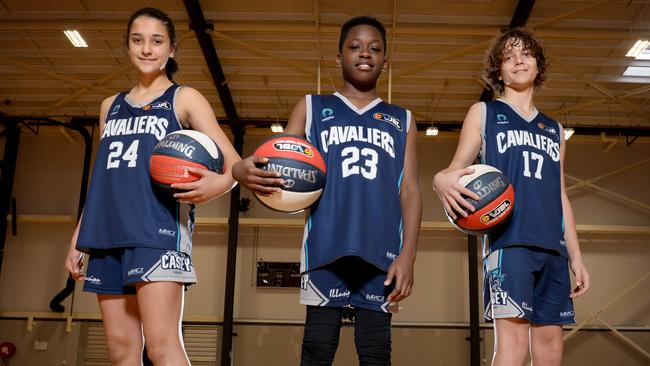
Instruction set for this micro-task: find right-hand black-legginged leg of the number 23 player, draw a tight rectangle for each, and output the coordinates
[354,309,391,366]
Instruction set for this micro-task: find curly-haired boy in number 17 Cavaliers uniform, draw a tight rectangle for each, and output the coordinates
[433,28,589,366]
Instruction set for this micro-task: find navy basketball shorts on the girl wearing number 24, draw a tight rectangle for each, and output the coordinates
[84,247,197,295]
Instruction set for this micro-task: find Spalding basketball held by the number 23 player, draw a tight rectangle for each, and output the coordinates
[254,135,326,212]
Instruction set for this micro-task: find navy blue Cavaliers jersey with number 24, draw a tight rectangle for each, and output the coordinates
[77,85,194,254]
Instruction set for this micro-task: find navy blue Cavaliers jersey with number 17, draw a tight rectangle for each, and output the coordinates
[479,99,567,257]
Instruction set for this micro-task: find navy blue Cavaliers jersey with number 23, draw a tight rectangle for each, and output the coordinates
[301,93,411,272]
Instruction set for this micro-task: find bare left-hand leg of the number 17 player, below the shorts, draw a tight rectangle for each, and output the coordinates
[492,318,530,366]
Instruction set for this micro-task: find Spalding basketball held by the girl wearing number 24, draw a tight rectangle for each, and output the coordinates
[149,130,224,188]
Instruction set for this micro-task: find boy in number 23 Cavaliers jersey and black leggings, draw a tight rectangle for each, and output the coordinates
[233,17,421,366]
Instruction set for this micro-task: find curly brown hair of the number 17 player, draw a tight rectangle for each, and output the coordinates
[482,27,549,94]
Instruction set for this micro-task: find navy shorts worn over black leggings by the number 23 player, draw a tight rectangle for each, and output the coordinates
[300,257,395,313]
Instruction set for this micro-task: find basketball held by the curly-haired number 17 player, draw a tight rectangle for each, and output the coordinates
[445,164,515,235]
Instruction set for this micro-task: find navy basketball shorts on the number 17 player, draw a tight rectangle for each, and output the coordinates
[483,246,575,325]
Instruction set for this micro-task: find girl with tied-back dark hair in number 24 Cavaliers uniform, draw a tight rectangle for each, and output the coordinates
[66,8,240,366]
